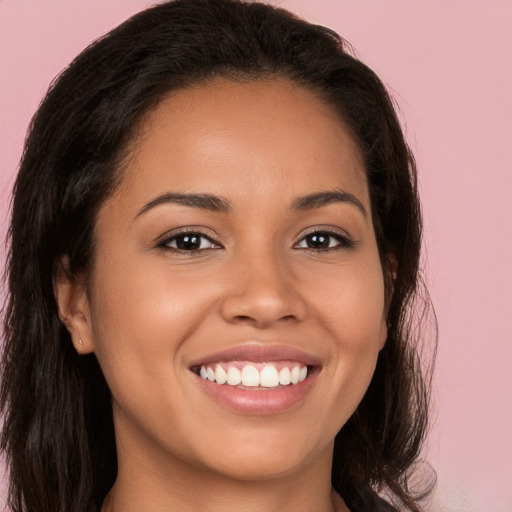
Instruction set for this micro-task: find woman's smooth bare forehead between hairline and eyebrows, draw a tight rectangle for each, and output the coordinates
[112,79,369,214]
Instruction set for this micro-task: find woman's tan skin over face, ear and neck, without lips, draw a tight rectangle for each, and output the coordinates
[55,79,386,512]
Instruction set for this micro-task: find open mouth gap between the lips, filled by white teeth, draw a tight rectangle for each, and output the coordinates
[191,361,313,391]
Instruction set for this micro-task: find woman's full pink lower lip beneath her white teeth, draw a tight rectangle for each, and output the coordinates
[196,368,318,415]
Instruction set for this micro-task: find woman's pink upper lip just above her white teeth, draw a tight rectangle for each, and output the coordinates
[190,342,321,368]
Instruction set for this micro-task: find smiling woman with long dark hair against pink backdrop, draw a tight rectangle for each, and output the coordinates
[1,0,434,512]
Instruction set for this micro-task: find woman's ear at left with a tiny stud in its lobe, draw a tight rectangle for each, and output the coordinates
[53,255,94,354]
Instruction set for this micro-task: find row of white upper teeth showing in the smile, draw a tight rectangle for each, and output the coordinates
[199,363,308,388]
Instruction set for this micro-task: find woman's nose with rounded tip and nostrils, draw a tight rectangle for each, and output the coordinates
[221,249,306,329]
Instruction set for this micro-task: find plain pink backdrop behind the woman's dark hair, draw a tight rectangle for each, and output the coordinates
[0,0,512,512]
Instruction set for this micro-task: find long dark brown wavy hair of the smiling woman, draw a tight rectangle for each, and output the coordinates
[0,0,435,512]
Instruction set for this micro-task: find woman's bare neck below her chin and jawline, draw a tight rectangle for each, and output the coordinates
[102,430,348,512]
